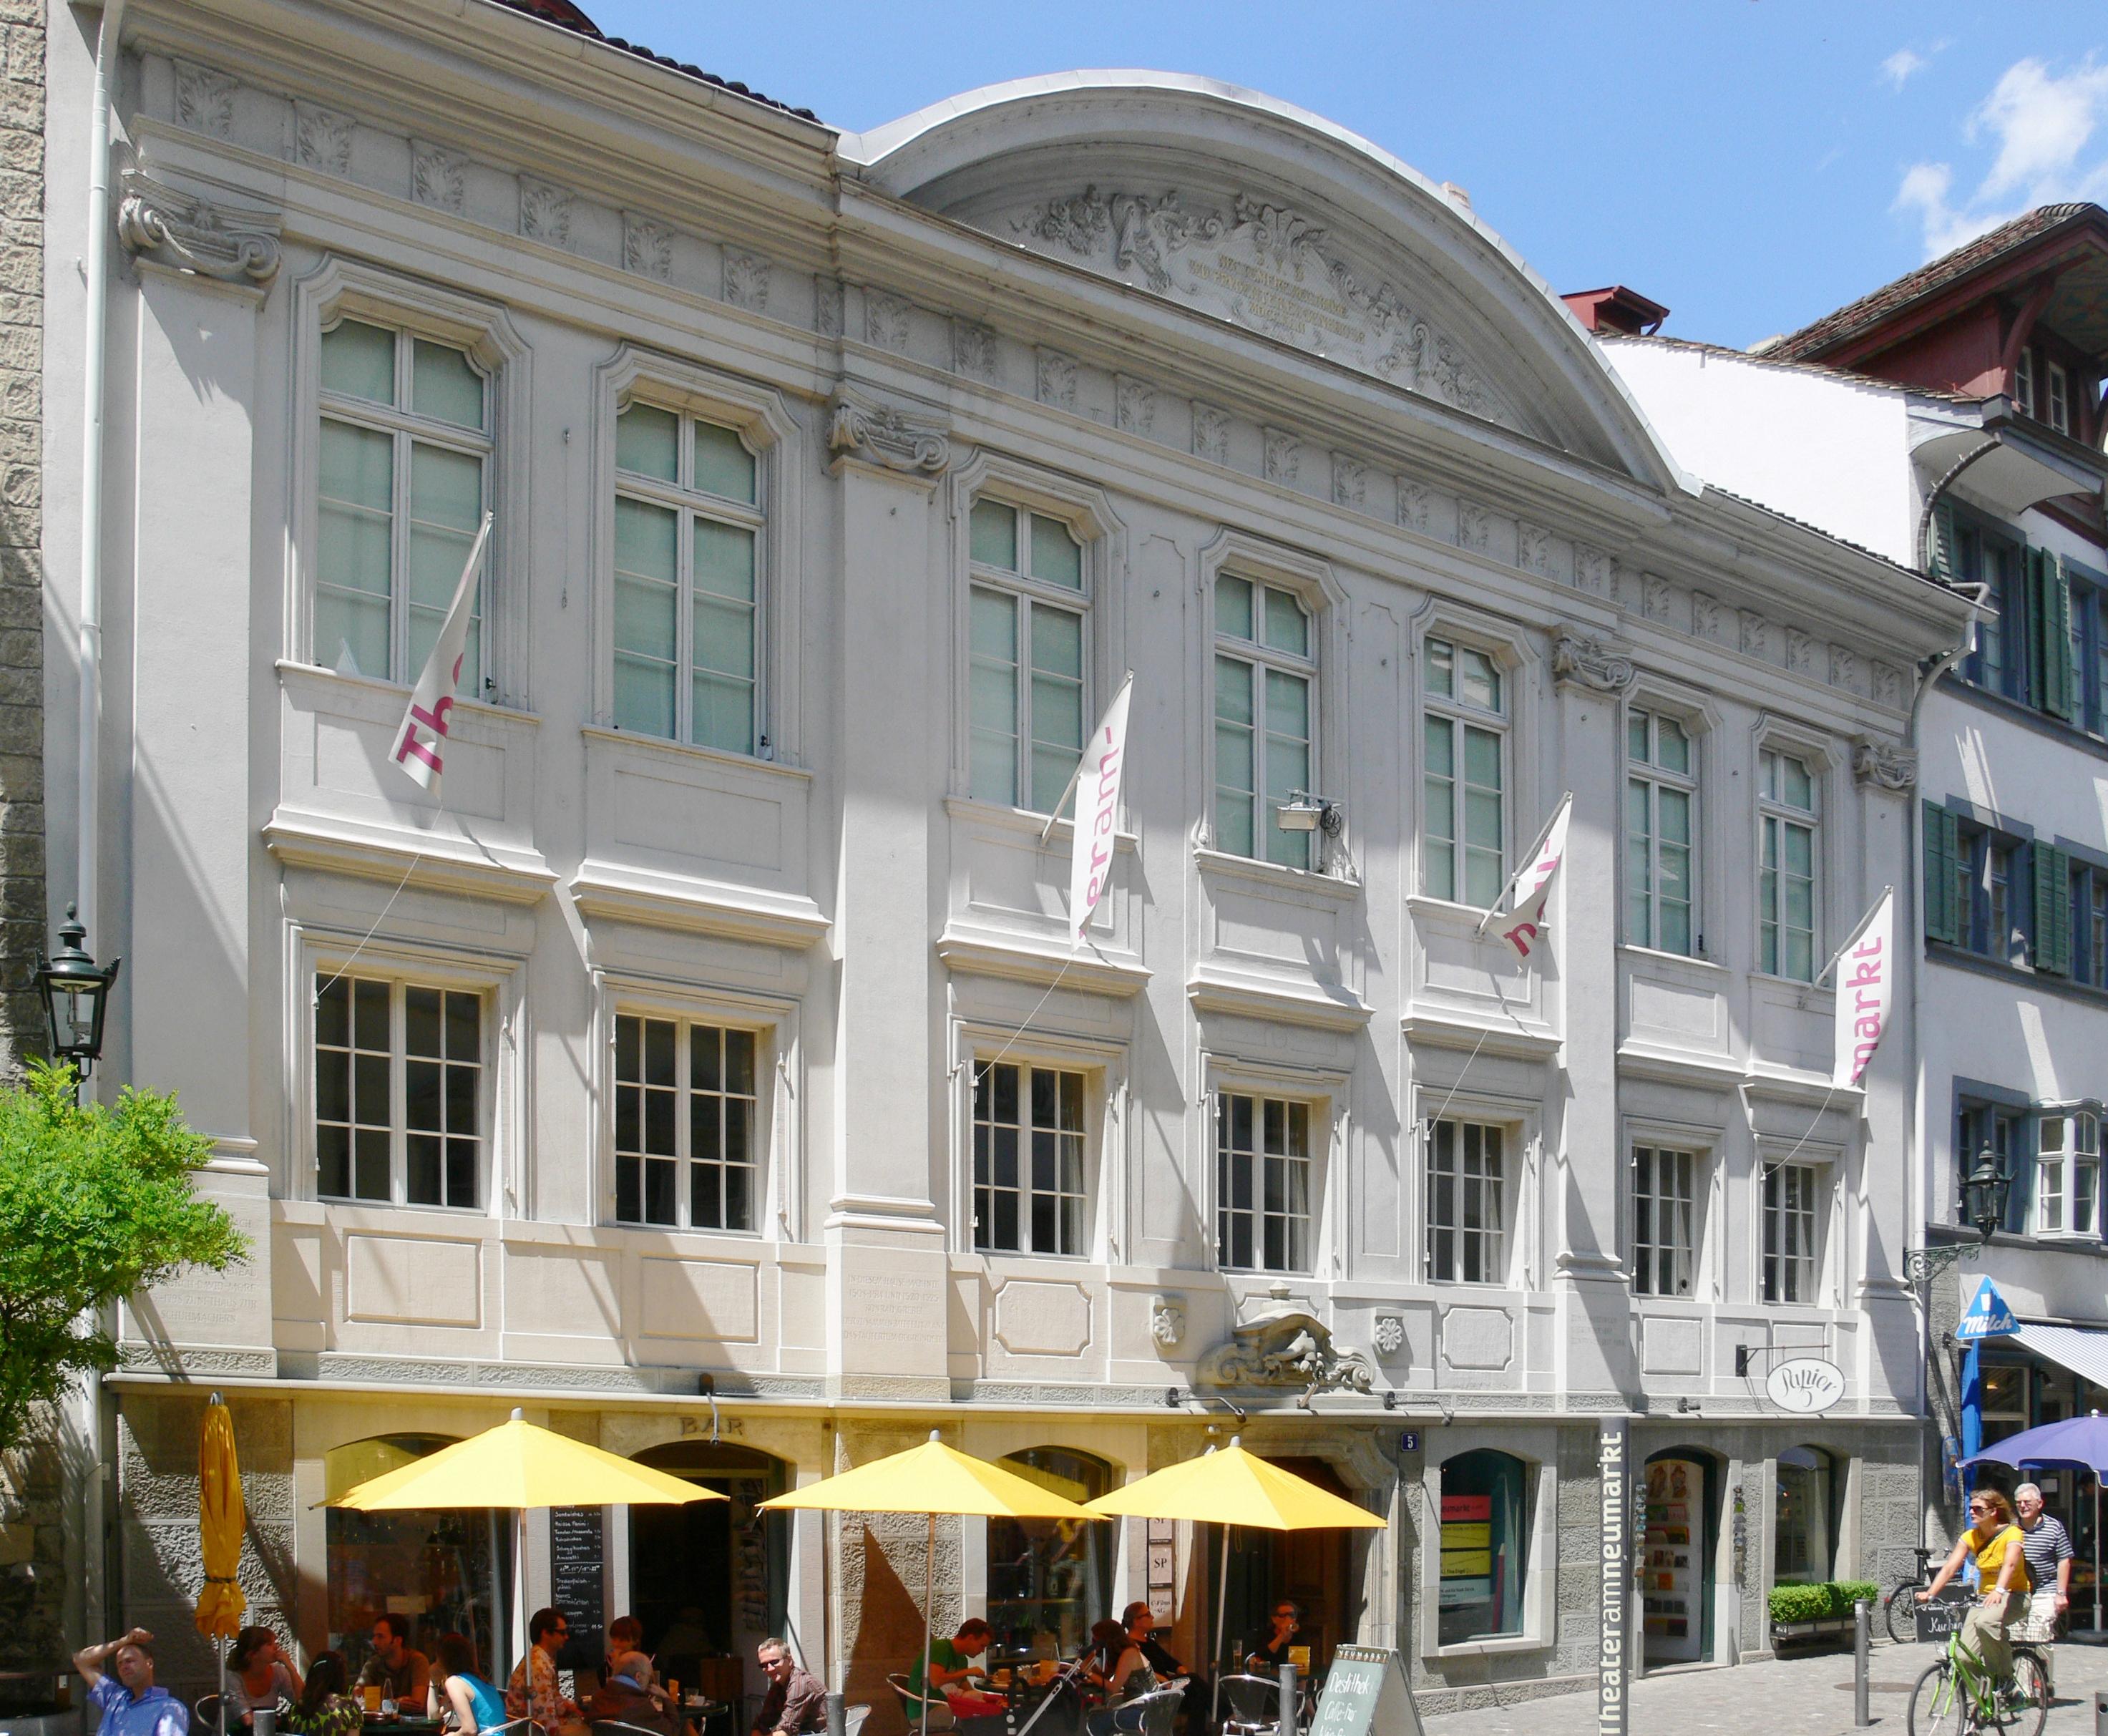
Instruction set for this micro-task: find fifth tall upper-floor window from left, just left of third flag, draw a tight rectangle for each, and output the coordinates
[1421,639,1507,909]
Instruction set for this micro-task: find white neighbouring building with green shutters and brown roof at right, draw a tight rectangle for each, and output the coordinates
[1609,205,2108,1586]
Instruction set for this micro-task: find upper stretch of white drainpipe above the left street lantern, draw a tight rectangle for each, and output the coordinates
[74,0,125,935]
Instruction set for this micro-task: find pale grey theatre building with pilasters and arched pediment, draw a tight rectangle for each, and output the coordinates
[47,0,1965,1723]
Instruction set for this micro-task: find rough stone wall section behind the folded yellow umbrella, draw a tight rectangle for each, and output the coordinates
[118,1393,295,1698]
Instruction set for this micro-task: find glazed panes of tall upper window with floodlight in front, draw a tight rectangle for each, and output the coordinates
[1214,574,1317,869]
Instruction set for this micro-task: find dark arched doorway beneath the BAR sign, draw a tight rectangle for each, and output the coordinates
[622,1440,791,1700]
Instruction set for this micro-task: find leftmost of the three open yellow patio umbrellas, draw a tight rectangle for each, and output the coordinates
[325,1411,727,1667]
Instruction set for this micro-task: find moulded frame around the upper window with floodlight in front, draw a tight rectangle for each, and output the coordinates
[1187,530,1347,877]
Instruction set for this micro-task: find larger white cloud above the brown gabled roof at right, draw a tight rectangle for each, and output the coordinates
[1885,49,2108,260]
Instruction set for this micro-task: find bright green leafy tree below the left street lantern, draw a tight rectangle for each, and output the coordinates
[0,1061,249,1451]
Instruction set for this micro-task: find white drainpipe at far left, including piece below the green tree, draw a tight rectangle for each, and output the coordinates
[74,0,125,1633]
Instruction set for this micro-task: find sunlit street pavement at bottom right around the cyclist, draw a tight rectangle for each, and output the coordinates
[1416,1643,2108,1736]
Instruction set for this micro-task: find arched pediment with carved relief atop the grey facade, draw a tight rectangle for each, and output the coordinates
[839,72,1678,487]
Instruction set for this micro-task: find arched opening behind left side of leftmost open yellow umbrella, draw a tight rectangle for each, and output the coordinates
[323,1434,512,1673]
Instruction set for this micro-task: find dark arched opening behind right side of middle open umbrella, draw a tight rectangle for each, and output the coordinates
[989,1447,1119,1658]
